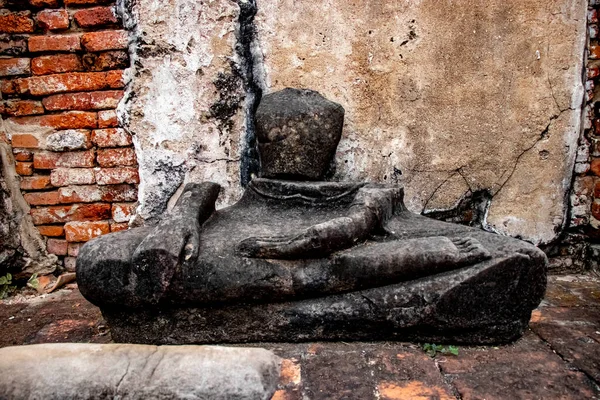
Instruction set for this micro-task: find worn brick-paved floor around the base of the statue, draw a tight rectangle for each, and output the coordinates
[0,276,600,400]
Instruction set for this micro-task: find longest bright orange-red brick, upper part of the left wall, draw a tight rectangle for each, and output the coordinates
[26,71,124,96]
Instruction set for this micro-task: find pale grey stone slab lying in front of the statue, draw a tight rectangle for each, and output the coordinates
[0,343,280,400]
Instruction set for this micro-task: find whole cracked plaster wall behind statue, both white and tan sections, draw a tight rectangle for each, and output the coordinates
[121,0,587,243]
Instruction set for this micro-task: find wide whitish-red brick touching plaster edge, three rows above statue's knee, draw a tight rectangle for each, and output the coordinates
[58,185,137,203]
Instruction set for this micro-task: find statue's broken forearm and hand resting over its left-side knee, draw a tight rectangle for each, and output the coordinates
[131,182,220,302]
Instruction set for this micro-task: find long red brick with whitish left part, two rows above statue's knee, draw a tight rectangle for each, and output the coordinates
[29,203,111,225]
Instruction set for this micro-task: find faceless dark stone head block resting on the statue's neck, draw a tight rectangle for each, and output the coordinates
[256,88,344,180]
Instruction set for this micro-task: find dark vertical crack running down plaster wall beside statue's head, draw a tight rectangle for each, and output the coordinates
[235,0,264,187]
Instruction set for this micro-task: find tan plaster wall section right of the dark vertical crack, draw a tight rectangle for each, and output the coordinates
[256,0,587,243]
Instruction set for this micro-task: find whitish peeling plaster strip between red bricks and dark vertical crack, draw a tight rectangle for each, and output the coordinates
[120,0,246,219]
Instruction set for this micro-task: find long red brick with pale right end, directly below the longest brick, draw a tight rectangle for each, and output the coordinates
[43,90,123,111]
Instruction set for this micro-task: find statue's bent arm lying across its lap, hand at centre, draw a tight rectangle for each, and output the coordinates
[238,186,402,258]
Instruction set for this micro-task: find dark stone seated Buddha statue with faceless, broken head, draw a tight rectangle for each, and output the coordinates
[77,89,547,344]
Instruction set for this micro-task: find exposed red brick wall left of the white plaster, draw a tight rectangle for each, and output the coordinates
[0,0,139,270]
